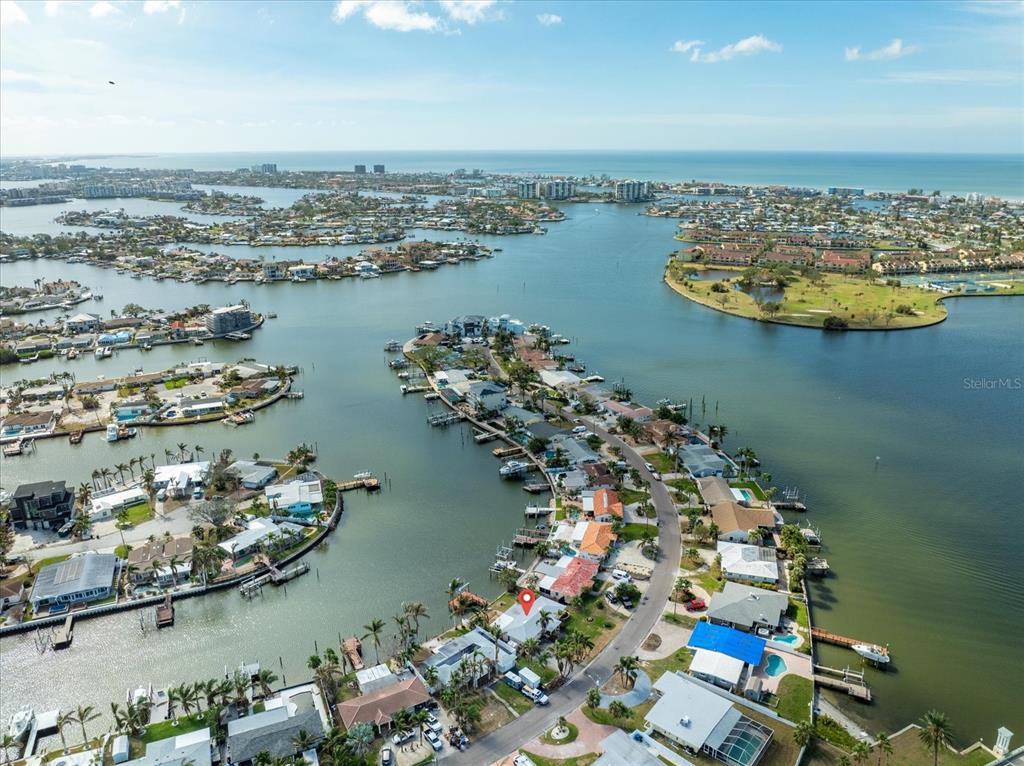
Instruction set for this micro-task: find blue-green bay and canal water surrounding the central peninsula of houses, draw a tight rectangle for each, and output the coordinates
[0,184,1024,741]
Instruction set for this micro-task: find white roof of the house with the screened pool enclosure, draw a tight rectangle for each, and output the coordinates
[646,671,733,752]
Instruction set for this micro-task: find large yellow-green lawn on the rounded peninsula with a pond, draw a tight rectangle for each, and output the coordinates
[666,263,974,330]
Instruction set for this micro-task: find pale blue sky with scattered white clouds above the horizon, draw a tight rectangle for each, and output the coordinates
[0,0,1024,156]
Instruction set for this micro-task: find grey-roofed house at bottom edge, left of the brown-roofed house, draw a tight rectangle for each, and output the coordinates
[224,686,325,766]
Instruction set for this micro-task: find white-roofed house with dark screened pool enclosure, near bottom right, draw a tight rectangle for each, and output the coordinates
[646,671,774,766]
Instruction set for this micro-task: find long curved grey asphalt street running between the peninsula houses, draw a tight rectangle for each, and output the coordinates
[442,409,680,764]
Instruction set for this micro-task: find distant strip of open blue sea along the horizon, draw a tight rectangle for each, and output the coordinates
[16,151,1024,200]
